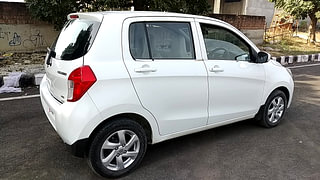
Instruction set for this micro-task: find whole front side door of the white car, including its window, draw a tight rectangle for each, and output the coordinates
[197,21,265,124]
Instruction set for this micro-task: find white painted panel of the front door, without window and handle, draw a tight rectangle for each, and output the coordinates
[196,19,265,124]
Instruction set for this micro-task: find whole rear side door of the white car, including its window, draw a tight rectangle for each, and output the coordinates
[123,17,208,135]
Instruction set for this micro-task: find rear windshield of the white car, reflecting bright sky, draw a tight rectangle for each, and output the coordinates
[51,19,100,60]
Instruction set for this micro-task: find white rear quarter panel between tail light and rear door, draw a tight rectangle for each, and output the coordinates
[84,14,159,143]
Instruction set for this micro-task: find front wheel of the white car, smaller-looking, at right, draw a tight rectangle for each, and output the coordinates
[255,90,288,128]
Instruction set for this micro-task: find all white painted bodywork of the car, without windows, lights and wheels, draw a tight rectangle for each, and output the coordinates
[40,12,293,145]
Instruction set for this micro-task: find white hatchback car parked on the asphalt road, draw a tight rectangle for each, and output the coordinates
[40,12,294,177]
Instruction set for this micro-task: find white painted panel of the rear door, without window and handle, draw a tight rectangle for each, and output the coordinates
[122,17,208,135]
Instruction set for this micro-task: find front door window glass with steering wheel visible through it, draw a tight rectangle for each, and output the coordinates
[200,24,250,61]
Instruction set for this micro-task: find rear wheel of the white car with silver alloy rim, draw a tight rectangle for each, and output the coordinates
[88,119,147,178]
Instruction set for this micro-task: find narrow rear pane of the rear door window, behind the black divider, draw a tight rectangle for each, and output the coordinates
[129,23,151,59]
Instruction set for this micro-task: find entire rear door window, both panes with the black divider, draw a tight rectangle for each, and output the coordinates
[129,22,195,60]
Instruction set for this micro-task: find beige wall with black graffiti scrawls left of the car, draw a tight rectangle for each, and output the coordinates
[0,28,48,48]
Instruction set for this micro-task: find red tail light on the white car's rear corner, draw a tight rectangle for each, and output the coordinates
[68,66,97,102]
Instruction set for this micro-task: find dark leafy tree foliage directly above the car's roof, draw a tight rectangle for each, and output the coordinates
[26,0,210,30]
